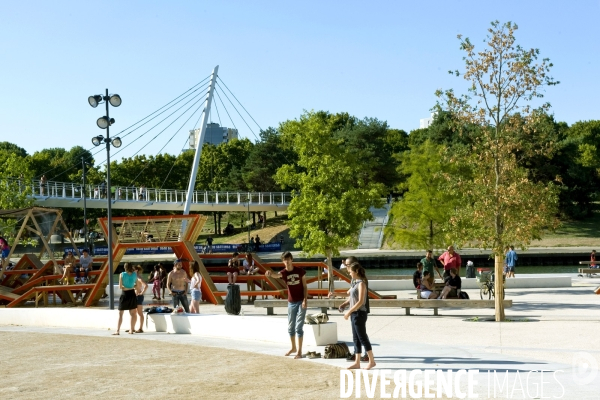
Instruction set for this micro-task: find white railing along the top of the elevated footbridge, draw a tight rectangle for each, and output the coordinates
[12,179,292,205]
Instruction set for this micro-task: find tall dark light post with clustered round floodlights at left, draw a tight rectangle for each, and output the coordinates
[88,89,122,310]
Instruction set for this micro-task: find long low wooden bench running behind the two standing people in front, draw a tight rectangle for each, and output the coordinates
[254,299,512,315]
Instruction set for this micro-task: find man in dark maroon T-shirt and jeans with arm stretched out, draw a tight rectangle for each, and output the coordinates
[265,251,308,358]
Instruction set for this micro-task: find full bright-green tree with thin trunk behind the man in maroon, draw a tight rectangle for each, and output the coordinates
[275,112,384,285]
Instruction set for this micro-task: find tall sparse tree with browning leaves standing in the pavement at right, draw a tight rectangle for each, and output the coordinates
[437,21,558,321]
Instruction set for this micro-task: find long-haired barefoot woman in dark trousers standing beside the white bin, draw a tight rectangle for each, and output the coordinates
[340,262,377,369]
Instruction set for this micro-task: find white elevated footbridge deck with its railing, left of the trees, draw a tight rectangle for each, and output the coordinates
[18,180,292,212]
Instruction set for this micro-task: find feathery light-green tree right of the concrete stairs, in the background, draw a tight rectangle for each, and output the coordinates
[387,140,458,249]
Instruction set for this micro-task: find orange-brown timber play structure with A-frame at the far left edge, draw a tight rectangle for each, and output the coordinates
[0,207,94,307]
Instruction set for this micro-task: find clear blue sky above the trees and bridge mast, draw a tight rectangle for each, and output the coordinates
[0,0,600,163]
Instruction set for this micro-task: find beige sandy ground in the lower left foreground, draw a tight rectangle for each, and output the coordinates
[0,332,350,399]
